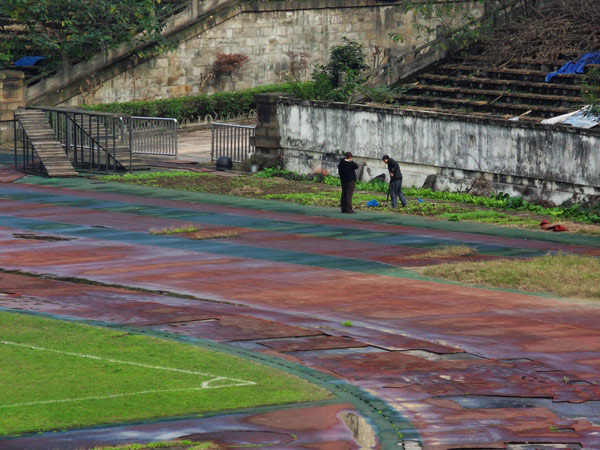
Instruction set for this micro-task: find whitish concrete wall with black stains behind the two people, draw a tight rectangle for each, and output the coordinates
[270,98,600,202]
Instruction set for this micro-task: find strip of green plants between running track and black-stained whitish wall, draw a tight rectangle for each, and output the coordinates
[102,168,600,234]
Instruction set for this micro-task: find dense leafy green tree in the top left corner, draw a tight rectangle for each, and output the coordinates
[0,0,179,68]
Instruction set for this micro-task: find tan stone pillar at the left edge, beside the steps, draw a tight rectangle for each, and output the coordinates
[0,70,25,144]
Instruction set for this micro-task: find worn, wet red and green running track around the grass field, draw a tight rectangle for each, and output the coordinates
[0,177,600,450]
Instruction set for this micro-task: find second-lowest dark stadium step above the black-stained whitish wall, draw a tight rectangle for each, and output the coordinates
[411,85,583,109]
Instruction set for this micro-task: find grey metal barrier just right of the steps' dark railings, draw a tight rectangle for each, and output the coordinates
[122,116,177,159]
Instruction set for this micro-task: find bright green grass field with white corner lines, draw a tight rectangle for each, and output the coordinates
[0,312,331,435]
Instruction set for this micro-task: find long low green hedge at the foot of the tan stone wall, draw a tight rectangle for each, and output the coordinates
[86,82,310,123]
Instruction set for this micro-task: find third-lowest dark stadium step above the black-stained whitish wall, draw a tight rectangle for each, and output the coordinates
[418,73,584,97]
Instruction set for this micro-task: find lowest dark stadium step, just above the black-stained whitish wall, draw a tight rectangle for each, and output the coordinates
[396,94,572,118]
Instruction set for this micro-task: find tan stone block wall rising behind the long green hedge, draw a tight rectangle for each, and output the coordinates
[28,0,483,105]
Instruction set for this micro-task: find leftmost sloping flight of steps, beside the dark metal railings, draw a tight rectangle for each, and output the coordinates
[15,110,77,177]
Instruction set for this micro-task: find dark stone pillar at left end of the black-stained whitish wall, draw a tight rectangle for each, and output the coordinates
[254,93,292,163]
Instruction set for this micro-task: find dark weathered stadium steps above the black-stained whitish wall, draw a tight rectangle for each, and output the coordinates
[396,56,593,122]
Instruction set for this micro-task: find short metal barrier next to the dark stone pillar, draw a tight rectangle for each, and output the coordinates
[210,123,256,162]
